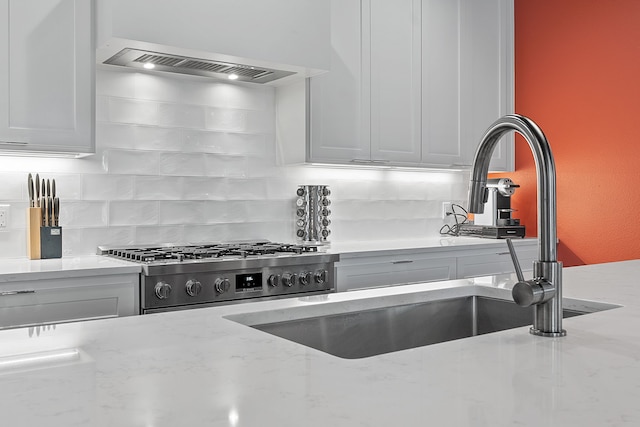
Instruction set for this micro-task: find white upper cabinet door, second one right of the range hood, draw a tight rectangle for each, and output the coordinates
[362,0,422,163]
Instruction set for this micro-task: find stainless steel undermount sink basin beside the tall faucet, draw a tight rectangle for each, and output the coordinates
[236,295,616,359]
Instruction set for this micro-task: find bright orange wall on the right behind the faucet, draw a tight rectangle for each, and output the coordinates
[500,0,640,266]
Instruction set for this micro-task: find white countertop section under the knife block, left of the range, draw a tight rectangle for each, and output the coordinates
[0,255,141,283]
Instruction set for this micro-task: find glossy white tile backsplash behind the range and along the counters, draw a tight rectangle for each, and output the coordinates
[0,69,468,258]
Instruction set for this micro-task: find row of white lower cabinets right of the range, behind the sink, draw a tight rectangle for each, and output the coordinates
[336,240,538,292]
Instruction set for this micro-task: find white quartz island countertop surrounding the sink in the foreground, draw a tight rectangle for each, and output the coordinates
[0,261,640,427]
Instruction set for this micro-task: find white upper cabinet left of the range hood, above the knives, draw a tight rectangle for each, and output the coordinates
[0,0,95,155]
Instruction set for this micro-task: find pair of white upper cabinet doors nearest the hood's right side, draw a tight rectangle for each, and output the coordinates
[307,0,421,165]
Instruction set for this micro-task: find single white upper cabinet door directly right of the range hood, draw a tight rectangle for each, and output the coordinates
[308,0,371,163]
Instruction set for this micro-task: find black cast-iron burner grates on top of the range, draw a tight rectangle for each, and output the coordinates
[103,241,318,263]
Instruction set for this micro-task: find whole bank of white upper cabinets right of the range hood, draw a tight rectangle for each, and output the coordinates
[306,0,513,170]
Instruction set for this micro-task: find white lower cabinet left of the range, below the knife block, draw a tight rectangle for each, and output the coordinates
[0,274,139,329]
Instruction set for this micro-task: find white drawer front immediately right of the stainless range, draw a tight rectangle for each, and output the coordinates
[336,257,456,292]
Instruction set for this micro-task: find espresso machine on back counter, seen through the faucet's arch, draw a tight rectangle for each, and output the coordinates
[460,178,525,239]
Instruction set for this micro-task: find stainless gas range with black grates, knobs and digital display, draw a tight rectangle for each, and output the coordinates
[98,240,339,314]
